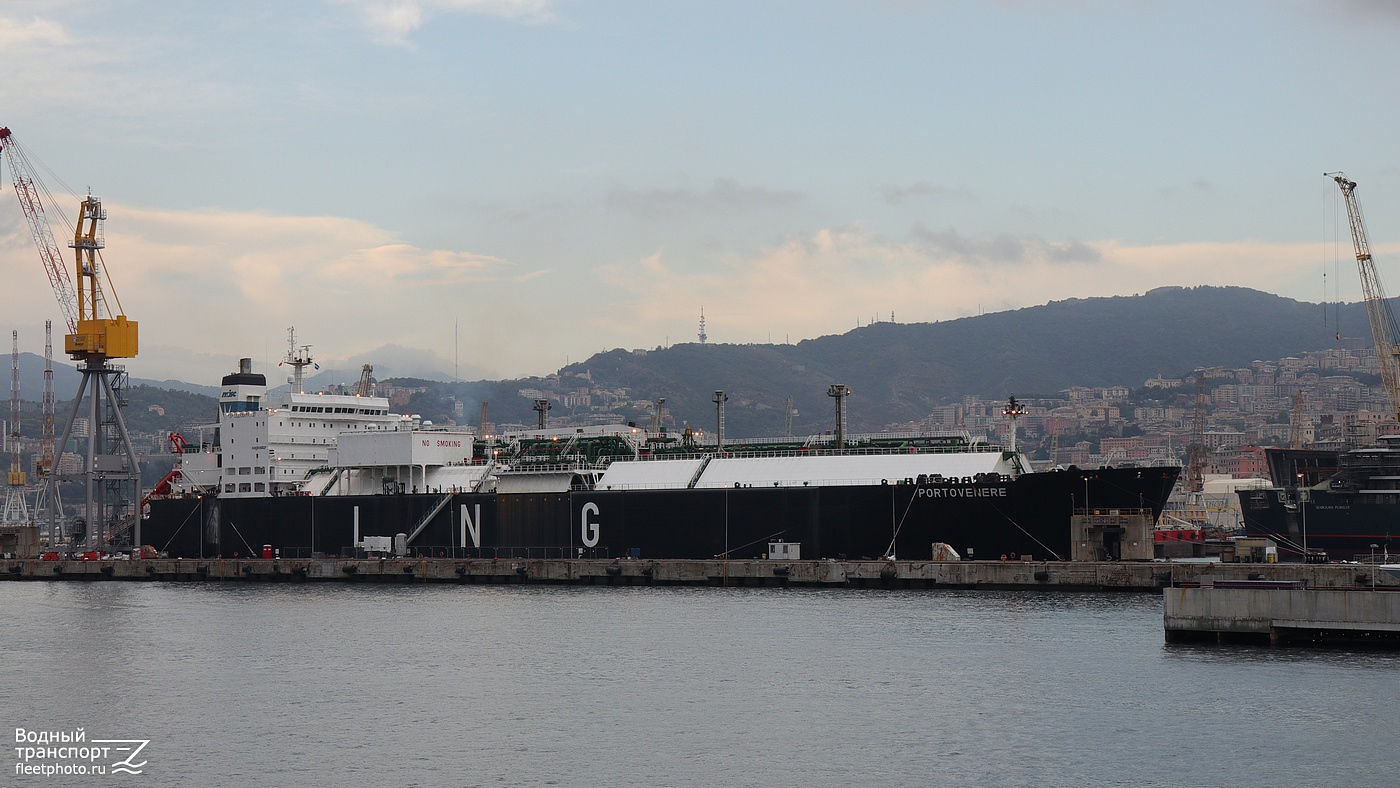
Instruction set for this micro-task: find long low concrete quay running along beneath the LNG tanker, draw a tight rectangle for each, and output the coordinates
[0,558,1400,591]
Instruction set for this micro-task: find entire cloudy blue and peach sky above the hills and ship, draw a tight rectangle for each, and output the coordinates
[0,0,1400,382]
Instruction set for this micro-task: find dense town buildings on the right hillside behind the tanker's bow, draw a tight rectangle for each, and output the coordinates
[925,343,1383,477]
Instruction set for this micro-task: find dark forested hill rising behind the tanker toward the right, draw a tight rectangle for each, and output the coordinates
[546,287,1369,435]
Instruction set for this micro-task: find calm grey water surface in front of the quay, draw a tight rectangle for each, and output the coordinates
[0,582,1400,788]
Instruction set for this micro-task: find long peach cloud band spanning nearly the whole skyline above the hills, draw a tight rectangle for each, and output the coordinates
[0,203,1366,382]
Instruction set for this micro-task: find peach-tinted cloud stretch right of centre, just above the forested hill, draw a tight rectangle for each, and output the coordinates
[599,227,1344,347]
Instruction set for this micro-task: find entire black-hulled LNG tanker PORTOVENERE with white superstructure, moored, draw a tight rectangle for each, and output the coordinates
[141,361,1180,560]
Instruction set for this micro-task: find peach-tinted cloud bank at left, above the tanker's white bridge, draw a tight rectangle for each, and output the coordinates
[0,203,519,382]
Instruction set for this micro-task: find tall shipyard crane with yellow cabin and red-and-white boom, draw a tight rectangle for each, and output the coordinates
[0,127,140,550]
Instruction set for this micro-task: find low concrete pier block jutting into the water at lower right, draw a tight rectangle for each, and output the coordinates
[1162,579,1400,648]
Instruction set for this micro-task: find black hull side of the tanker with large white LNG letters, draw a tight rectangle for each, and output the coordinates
[141,467,1179,558]
